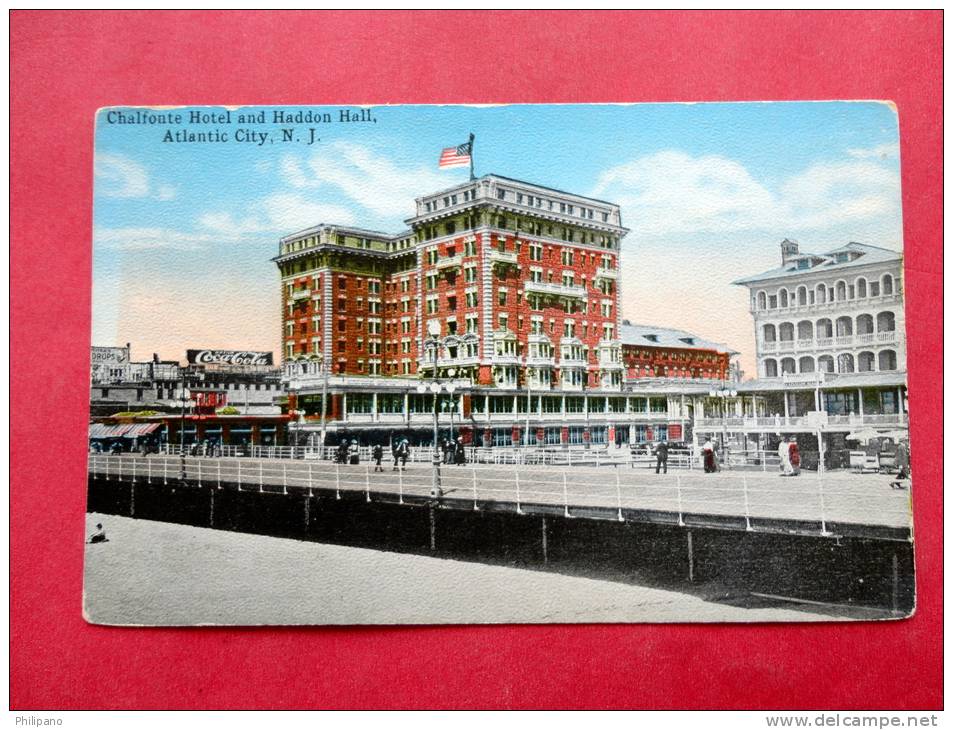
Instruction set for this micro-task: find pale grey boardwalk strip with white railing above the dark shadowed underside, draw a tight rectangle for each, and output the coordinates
[89,455,911,539]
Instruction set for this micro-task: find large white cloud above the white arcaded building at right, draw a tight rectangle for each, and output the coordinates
[593,150,900,235]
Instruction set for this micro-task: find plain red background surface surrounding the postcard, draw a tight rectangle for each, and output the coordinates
[10,11,942,709]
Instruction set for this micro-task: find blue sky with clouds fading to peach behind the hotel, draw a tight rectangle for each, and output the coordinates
[93,102,902,372]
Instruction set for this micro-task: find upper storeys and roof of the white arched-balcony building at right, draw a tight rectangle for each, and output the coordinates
[735,239,906,378]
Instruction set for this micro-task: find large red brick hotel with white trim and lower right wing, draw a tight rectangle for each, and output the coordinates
[274,175,732,444]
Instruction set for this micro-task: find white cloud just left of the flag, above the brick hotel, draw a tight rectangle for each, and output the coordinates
[282,142,453,219]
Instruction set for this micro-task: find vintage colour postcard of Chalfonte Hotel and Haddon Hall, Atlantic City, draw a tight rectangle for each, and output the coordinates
[84,101,916,625]
